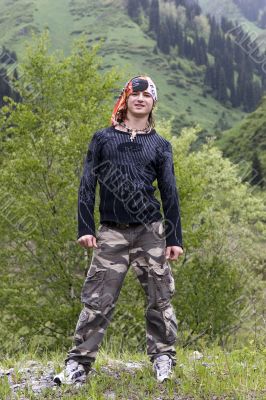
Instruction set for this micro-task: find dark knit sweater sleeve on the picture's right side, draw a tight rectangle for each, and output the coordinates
[157,142,183,248]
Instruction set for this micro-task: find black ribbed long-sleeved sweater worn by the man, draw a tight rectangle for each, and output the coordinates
[78,126,183,248]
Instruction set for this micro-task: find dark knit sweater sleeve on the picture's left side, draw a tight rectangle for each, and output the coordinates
[77,133,102,238]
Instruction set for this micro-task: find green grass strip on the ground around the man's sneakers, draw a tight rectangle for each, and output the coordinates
[0,348,266,400]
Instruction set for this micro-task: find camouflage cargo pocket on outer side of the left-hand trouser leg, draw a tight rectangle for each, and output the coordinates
[81,266,106,309]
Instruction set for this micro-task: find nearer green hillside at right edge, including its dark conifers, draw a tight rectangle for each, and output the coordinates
[217,97,266,187]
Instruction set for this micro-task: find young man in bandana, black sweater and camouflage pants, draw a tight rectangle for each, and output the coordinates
[54,76,183,384]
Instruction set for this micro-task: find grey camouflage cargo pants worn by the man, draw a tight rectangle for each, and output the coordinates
[65,221,177,365]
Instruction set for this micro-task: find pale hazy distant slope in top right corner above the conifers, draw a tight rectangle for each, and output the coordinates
[199,0,266,49]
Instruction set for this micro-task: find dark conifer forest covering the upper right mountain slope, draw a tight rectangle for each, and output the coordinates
[128,0,266,112]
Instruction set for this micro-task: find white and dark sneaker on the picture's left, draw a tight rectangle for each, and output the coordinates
[53,360,86,385]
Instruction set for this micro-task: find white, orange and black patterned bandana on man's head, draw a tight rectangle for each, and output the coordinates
[111,76,157,125]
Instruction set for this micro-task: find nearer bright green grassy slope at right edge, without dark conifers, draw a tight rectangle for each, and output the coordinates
[216,97,266,177]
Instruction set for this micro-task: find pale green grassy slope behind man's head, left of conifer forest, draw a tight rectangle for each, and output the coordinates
[0,0,243,133]
